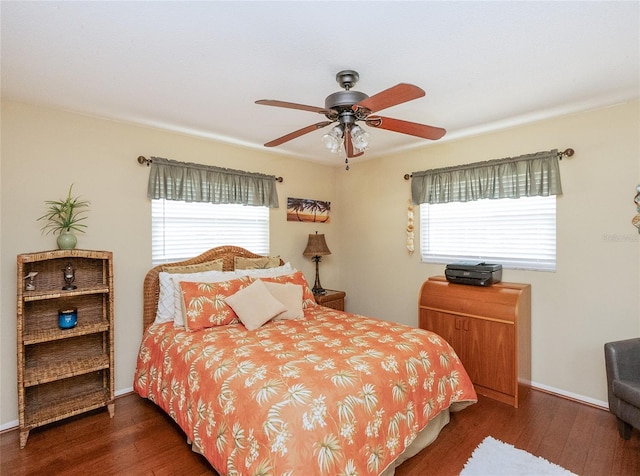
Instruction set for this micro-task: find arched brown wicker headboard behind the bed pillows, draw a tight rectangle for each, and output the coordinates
[142,246,284,330]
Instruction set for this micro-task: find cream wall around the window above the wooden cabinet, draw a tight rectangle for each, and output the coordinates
[337,101,640,405]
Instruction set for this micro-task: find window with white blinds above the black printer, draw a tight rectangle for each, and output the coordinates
[420,195,556,271]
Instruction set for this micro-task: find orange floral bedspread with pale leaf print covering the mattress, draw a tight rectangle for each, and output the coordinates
[134,306,477,476]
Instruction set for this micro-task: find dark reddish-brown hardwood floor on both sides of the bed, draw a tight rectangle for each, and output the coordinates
[0,390,640,476]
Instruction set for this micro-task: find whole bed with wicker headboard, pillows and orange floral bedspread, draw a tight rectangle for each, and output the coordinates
[134,246,477,476]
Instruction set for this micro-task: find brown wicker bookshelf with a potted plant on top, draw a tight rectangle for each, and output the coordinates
[17,250,115,448]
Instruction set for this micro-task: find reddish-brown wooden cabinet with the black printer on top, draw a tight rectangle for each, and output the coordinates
[419,276,531,407]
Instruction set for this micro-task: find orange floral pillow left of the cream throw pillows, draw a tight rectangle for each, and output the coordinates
[180,276,253,332]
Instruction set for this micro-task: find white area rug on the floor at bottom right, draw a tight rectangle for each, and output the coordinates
[460,436,575,476]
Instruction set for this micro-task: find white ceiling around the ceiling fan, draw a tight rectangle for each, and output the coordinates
[0,1,640,165]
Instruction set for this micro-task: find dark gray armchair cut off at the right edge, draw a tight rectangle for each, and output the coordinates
[604,338,640,440]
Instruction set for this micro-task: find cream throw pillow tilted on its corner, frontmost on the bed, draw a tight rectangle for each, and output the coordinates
[225,279,287,331]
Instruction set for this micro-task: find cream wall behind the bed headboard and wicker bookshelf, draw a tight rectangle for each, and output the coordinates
[0,101,341,429]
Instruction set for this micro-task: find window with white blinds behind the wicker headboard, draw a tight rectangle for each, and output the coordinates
[151,199,269,266]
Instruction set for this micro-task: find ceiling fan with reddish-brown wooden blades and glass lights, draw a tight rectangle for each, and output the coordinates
[256,70,446,170]
